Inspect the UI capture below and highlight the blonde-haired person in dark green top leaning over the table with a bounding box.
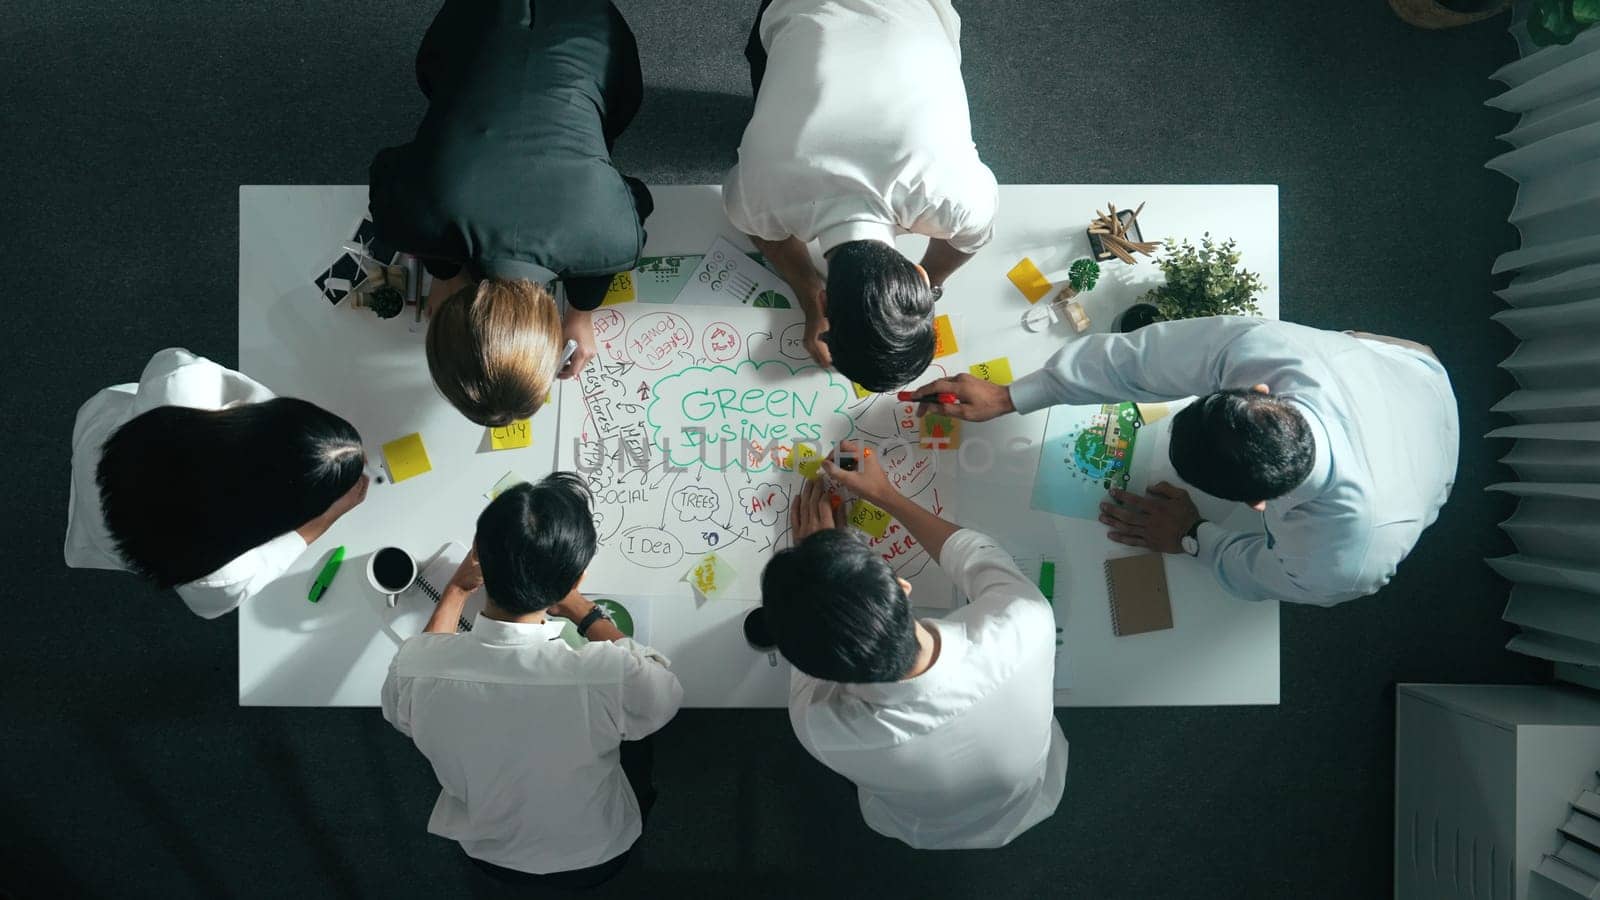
[368,0,654,426]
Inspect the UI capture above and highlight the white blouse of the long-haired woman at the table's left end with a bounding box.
[64,348,306,618]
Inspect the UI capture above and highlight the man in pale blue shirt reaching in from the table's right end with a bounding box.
[917,315,1461,605]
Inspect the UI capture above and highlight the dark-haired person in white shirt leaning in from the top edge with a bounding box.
[722,0,998,391]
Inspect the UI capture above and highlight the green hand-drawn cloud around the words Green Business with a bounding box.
[645,359,856,472]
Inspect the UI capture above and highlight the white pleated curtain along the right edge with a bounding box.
[1488,26,1600,687]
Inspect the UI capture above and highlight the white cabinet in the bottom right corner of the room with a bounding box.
[1395,684,1600,900]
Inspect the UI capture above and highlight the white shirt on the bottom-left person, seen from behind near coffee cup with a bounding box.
[382,613,683,874]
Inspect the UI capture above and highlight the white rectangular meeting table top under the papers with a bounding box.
[238,184,1280,706]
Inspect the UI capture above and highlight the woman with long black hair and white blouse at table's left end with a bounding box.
[64,348,368,618]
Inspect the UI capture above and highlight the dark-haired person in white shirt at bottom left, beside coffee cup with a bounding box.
[382,472,683,887]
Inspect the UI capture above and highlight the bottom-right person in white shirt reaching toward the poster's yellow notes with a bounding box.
[762,440,1067,850]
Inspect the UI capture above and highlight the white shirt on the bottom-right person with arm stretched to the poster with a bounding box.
[789,528,1067,850]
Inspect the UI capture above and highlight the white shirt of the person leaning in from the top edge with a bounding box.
[722,0,1000,253]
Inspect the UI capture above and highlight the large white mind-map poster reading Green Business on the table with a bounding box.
[557,304,960,609]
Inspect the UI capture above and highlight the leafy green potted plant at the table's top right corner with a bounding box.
[1117,234,1267,331]
